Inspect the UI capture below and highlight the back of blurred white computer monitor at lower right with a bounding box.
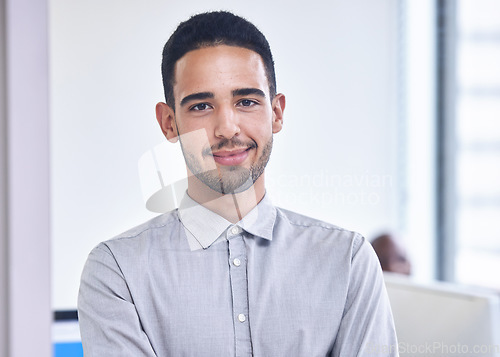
[385,274,500,357]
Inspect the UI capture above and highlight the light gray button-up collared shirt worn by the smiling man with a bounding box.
[78,195,397,357]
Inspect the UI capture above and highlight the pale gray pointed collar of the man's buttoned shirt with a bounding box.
[179,192,276,250]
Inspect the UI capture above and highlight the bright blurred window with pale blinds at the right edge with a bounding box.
[438,0,500,289]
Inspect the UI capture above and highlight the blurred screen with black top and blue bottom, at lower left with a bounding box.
[52,310,83,357]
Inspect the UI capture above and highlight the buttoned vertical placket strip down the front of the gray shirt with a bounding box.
[227,226,252,357]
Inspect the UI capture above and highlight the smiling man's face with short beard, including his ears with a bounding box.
[161,45,285,194]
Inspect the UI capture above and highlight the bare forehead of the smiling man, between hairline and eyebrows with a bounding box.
[174,45,269,100]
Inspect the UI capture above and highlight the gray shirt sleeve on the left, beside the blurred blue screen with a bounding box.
[78,244,156,357]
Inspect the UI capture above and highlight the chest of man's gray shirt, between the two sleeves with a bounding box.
[122,236,347,356]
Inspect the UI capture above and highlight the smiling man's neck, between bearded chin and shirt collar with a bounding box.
[188,174,265,223]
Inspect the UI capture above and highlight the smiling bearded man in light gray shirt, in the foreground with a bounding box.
[79,12,397,357]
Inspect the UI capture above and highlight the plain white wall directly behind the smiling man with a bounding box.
[50,0,401,309]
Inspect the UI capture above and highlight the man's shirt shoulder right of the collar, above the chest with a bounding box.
[275,207,367,256]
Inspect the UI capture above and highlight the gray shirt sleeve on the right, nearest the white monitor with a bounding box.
[332,235,399,357]
